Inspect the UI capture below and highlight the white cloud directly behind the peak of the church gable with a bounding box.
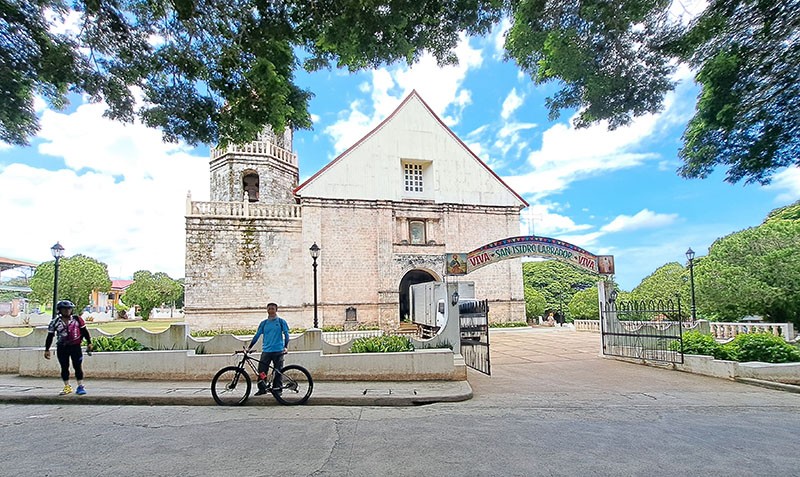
[324,37,483,154]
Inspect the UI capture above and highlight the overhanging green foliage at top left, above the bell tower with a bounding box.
[0,0,501,145]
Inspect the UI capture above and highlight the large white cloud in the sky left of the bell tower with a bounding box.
[0,104,209,278]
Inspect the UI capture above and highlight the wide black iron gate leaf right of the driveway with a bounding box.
[601,299,683,363]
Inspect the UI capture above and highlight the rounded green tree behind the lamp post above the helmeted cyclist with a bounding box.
[30,255,111,313]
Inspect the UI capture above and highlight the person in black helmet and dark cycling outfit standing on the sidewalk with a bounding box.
[44,300,92,396]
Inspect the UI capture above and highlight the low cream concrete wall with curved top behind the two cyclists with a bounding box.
[0,323,467,381]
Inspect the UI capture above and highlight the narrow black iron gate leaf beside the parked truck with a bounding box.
[458,300,492,375]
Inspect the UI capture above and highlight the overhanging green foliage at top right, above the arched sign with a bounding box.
[506,0,800,183]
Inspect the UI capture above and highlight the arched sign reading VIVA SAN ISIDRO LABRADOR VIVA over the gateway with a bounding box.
[462,235,600,273]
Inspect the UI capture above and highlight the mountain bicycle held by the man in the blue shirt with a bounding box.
[211,349,314,406]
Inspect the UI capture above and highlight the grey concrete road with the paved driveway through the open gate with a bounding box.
[0,330,800,476]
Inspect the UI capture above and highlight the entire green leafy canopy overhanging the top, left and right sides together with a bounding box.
[0,0,800,182]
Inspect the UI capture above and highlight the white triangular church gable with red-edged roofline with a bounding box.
[294,90,528,208]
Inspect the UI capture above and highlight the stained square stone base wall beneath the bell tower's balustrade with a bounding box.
[184,216,308,329]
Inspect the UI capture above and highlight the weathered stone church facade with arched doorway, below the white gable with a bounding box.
[301,198,525,328]
